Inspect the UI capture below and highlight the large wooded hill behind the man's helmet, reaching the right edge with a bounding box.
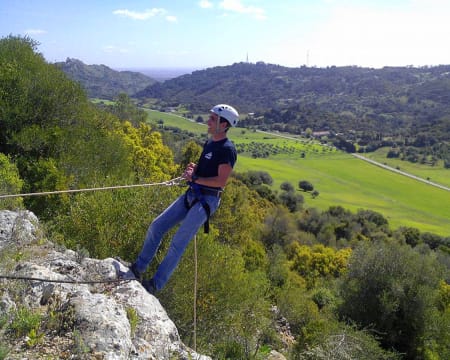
[136,63,450,146]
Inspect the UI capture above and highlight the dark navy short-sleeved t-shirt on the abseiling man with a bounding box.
[195,138,237,183]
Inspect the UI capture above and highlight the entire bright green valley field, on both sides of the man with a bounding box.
[147,112,450,236]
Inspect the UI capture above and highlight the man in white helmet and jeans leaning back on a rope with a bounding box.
[131,104,239,294]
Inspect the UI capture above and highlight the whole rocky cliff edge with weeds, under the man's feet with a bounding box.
[0,211,210,360]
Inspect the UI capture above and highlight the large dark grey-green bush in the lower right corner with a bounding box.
[339,241,442,359]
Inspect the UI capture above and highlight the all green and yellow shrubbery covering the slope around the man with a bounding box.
[0,36,450,360]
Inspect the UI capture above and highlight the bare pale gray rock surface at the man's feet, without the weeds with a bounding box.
[0,211,210,360]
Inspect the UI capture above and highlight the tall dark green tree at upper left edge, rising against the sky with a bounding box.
[0,36,85,157]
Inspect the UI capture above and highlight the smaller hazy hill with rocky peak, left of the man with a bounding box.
[55,58,156,99]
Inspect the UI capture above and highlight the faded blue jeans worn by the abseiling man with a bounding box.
[135,191,220,290]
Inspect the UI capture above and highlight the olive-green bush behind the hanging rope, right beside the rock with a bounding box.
[160,233,270,359]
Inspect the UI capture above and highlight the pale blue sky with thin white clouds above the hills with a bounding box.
[0,0,450,69]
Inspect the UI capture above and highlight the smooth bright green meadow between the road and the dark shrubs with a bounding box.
[236,153,450,236]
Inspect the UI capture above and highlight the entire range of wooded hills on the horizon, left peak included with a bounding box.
[61,59,450,168]
